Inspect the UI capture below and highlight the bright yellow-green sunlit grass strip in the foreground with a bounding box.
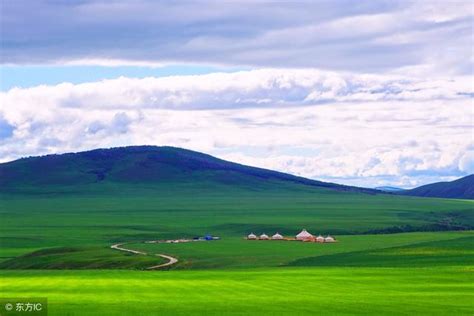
[0,267,474,315]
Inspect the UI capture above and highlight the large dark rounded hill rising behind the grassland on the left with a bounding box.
[0,146,380,194]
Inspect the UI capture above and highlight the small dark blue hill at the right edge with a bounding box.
[399,174,474,200]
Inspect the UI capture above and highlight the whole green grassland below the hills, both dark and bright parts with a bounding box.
[0,186,474,315]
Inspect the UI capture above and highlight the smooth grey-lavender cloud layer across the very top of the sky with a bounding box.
[0,0,474,75]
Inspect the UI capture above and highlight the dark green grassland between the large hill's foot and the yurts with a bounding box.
[0,185,474,267]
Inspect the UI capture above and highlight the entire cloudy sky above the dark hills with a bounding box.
[0,0,474,188]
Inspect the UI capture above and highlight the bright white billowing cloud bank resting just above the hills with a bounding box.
[0,69,474,187]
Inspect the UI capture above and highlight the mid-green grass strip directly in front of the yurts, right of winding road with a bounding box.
[128,232,474,269]
